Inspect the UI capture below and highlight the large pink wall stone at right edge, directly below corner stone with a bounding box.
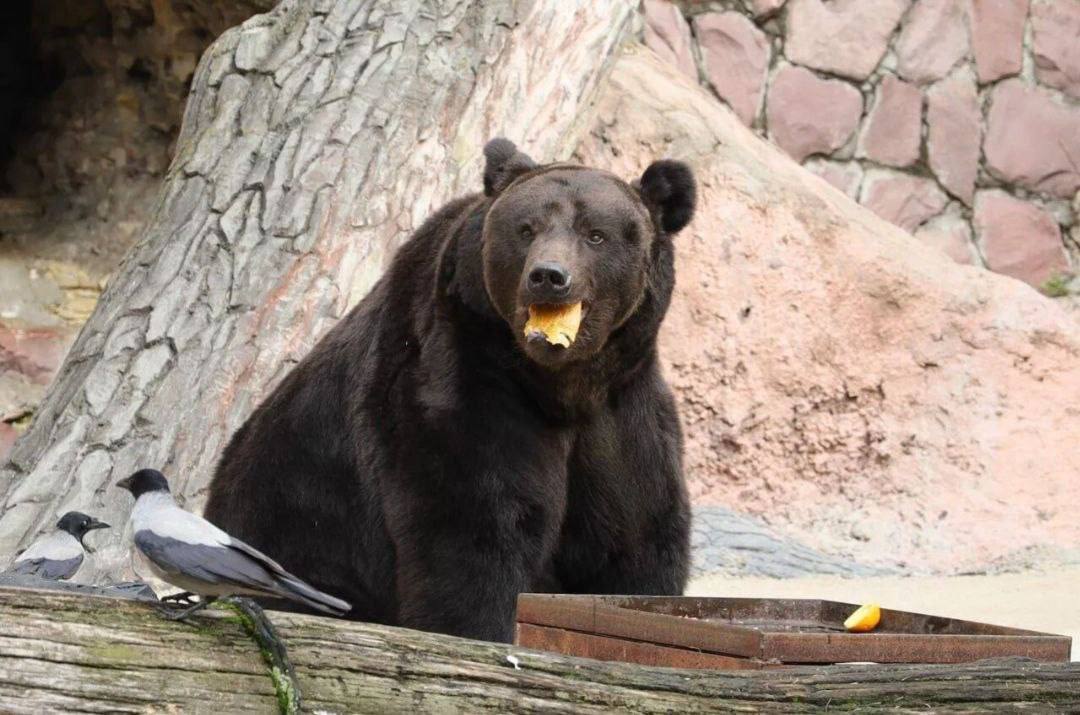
[983,80,1080,199]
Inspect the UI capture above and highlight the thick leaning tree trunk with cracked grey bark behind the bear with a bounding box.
[0,0,636,581]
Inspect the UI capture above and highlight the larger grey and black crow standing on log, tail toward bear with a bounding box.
[117,469,352,619]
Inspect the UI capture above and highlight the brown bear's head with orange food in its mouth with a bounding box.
[482,138,696,368]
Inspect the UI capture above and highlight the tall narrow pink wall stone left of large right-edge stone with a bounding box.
[927,68,983,206]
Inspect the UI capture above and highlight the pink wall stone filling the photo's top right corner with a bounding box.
[1031,0,1080,98]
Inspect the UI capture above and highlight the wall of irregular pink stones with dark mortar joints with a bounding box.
[644,0,1080,296]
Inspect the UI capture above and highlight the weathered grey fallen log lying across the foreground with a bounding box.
[0,589,1080,713]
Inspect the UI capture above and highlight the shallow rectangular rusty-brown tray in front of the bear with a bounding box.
[515,593,1072,669]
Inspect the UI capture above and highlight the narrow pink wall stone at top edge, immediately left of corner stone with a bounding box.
[970,0,1028,82]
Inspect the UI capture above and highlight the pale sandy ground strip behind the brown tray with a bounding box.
[687,567,1080,660]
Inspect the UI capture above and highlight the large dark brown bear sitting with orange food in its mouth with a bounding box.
[206,139,696,640]
